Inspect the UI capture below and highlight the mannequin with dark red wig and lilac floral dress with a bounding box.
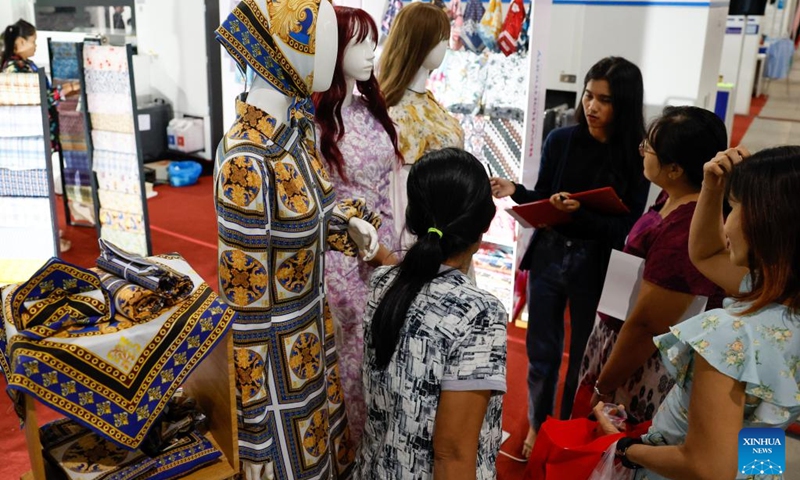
[313,7,402,445]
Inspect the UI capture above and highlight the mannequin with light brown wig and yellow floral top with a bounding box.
[379,2,464,249]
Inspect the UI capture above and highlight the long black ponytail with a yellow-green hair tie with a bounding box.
[370,148,495,370]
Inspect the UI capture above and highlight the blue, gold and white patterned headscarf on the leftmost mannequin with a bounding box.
[217,0,321,124]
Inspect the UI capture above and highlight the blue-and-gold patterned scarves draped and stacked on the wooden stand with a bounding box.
[0,246,235,479]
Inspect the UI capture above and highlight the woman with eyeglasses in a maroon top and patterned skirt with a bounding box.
[572,107,728,421]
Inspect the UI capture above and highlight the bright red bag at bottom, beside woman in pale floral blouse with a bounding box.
[523,417,651,480]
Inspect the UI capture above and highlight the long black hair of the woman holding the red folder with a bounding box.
[575,57,645,197]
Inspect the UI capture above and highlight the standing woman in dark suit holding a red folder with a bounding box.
[492,57,649,457]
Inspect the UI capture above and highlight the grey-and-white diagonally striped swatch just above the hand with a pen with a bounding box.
[483,118,525,182]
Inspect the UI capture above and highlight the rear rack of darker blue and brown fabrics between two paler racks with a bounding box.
[47,38,97,227]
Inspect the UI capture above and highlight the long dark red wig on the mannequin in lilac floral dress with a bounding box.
[312,7,403,181]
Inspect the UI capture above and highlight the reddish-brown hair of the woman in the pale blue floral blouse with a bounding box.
[728,146,800,315]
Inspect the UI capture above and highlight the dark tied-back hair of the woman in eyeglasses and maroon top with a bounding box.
[647,107,728,191]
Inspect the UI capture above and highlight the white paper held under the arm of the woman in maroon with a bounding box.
[597,250,708,322]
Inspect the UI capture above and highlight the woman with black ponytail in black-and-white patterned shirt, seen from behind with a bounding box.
[356,148,508,479]
